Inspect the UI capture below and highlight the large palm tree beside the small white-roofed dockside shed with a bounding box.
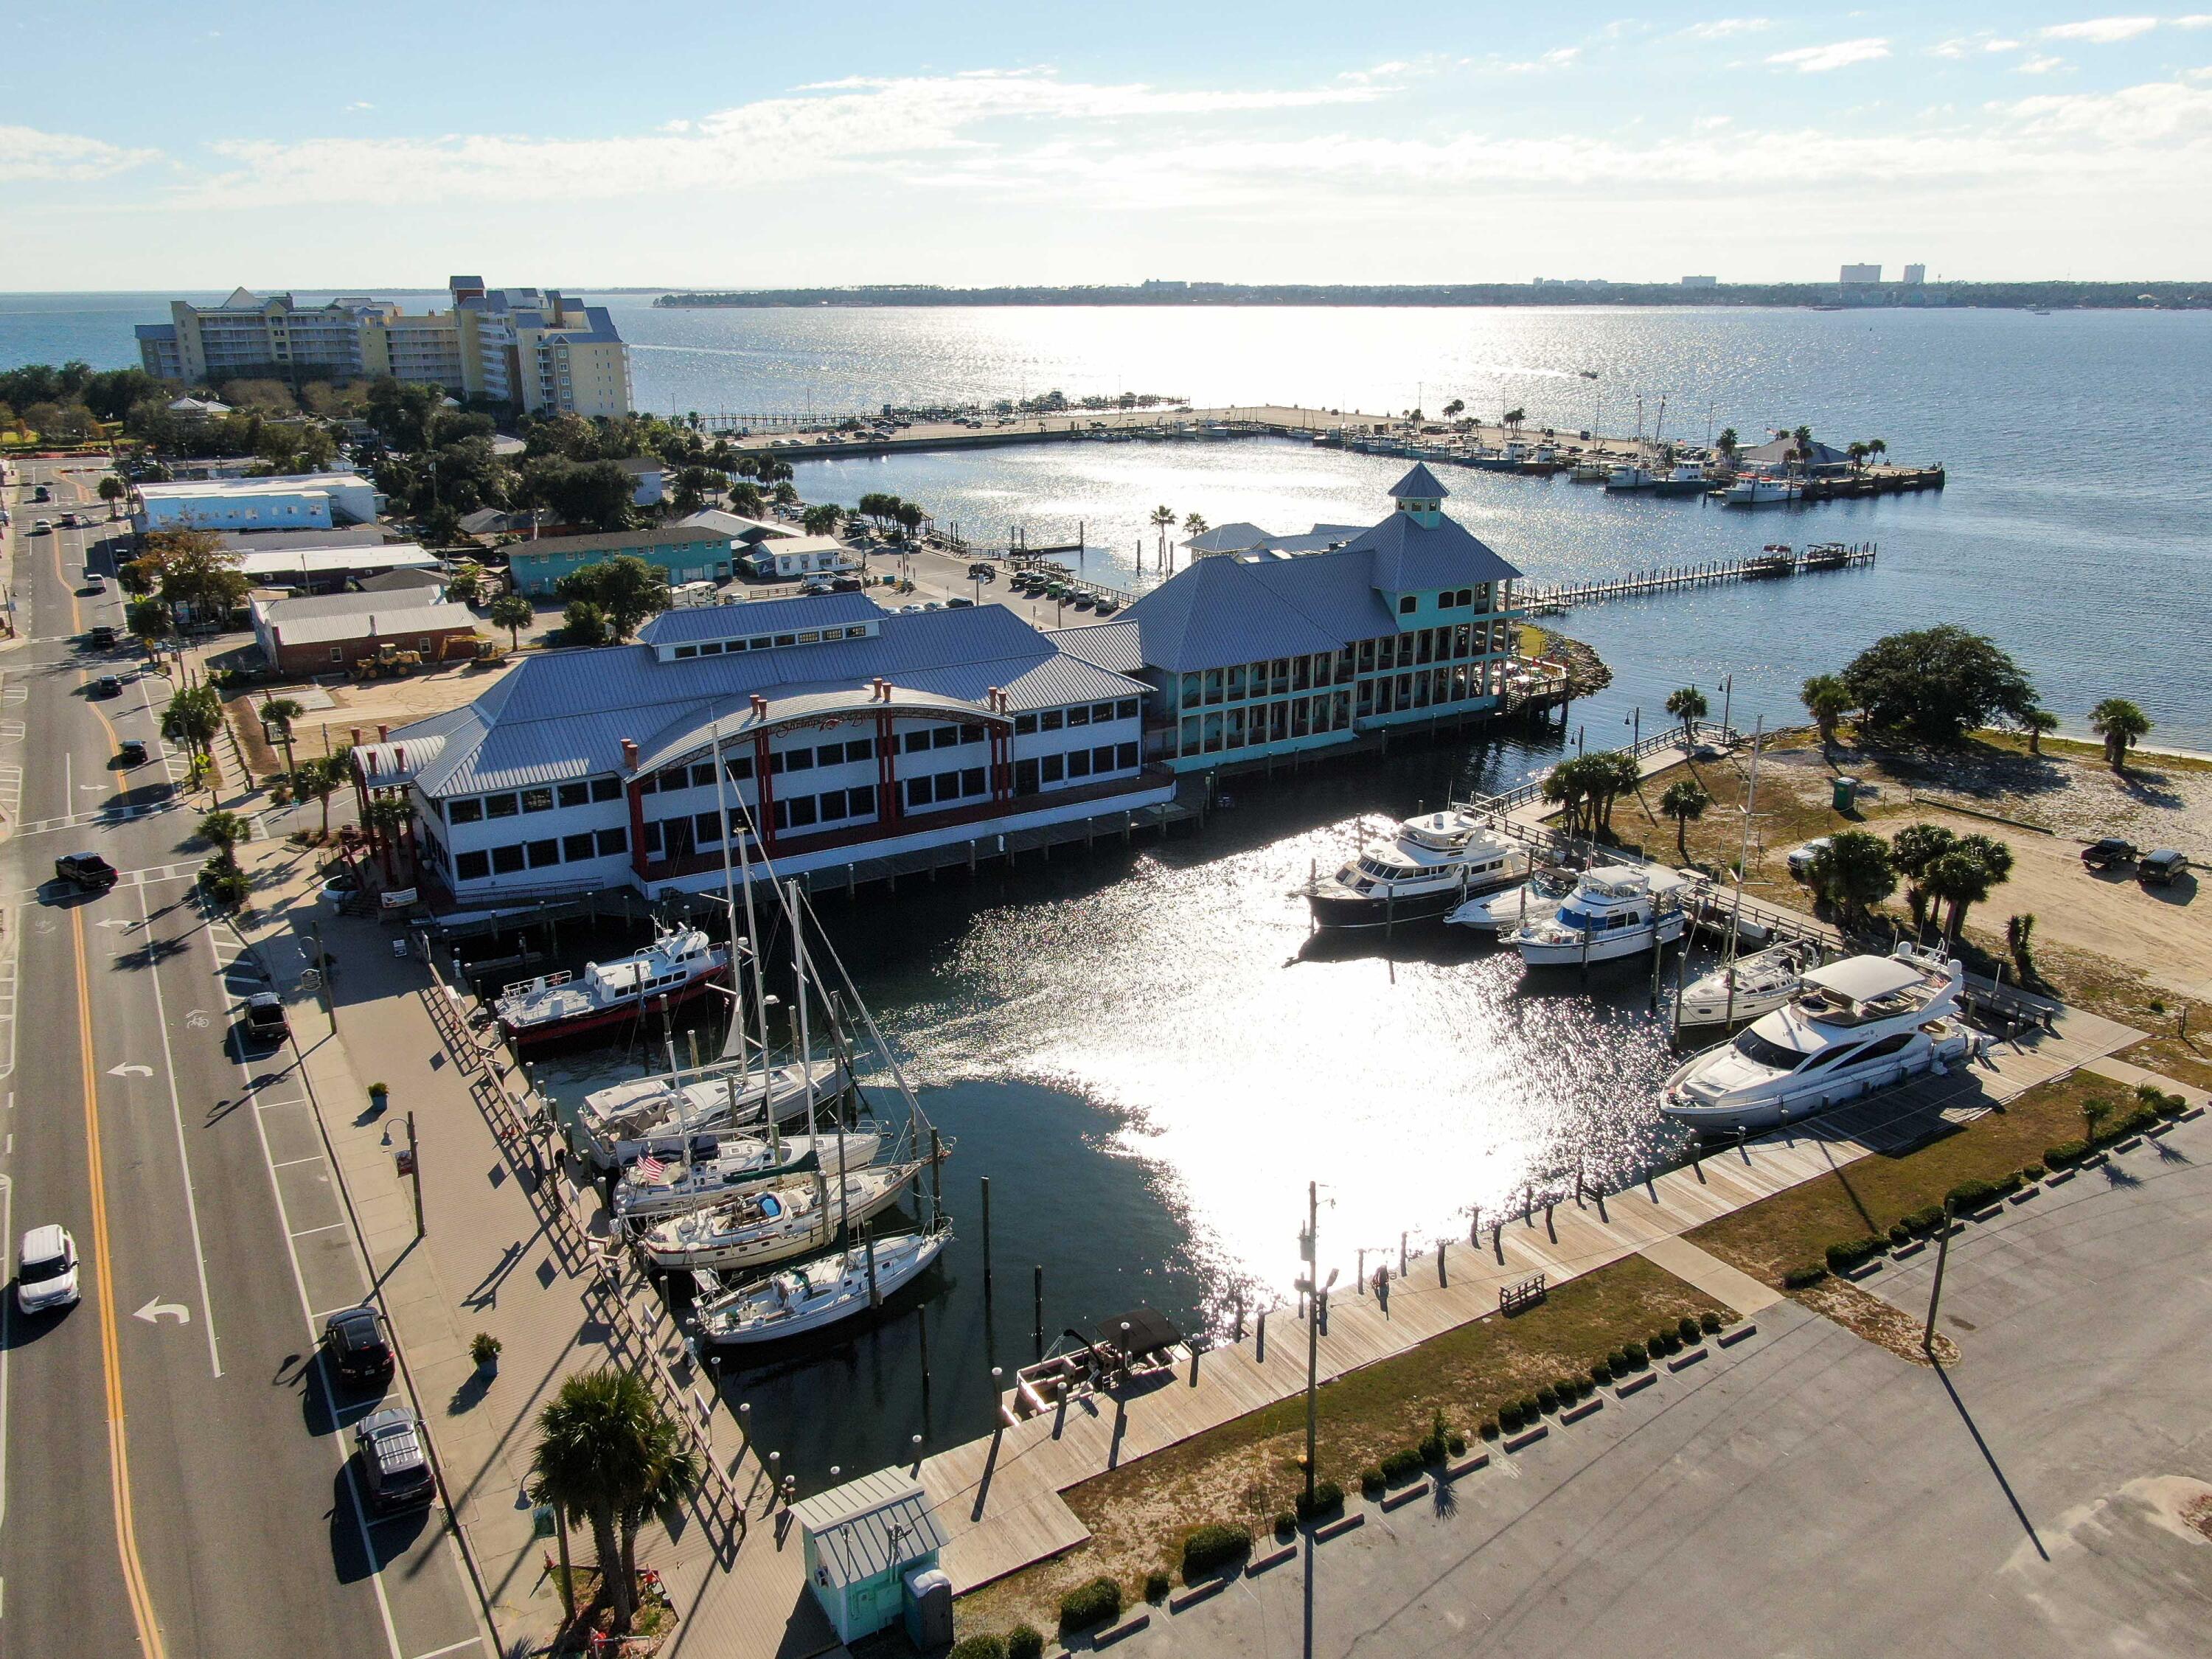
[531,1367,701,1635]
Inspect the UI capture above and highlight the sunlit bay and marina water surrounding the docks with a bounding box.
[17,296,2212,1480]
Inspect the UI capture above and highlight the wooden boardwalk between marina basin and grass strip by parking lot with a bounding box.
[920,1011,2139,1593]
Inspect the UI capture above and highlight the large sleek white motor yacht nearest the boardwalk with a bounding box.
[1661,942,1978,1135]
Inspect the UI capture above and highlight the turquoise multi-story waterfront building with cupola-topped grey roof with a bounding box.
[1051,465,1522,772]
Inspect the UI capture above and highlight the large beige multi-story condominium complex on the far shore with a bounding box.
[137,276,630,416]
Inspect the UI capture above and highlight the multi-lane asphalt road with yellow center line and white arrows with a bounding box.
[0,462,489,1659]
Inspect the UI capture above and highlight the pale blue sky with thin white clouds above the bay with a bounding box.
[0,0,2212,292]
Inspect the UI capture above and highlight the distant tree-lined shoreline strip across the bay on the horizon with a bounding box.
[653,281,2212,312]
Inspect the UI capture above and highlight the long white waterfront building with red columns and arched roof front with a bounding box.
[354,593,1175,905]
